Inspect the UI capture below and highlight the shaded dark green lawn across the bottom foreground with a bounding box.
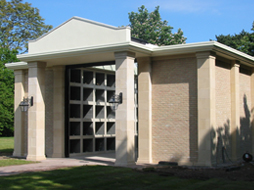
[0,166,254,190]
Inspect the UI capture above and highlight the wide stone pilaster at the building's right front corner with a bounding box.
[196,52,215,166]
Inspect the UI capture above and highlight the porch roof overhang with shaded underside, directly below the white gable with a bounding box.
[14,42,152,66]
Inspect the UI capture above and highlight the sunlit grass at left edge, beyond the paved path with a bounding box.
[0,137,35,167]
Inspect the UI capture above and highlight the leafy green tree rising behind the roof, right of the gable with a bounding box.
[128,5,186,46]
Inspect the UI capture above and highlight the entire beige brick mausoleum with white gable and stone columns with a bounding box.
[6,17,254,166]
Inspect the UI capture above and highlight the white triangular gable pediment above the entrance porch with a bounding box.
[28,16,131,54]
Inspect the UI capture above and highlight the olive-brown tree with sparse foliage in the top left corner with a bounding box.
[0,0,52,53]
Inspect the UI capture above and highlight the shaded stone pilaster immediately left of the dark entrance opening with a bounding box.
[52,66,65,158]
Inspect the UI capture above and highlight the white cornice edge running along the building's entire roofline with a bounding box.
[6,41,254,69]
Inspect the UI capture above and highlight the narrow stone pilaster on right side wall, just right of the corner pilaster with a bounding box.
[230,61,240,161]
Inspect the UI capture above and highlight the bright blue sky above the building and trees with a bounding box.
[23,0,254,43]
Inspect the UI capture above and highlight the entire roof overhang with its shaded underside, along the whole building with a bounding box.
[6,41,254,70]
